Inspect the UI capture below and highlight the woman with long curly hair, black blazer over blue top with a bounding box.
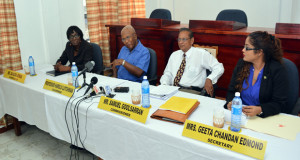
[224,31,288,117]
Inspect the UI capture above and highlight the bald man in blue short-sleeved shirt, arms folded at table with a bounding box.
[111,25,150,82]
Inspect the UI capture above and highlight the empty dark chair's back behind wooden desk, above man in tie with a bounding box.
[216,9,248,26]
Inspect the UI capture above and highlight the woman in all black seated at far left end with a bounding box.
[54,26,93,72]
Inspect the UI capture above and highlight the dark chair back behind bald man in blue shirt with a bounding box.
[146,47,157,85]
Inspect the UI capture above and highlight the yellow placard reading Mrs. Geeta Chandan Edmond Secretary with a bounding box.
[182,120,267,159]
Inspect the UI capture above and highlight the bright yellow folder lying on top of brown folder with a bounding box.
[159,96,198,114]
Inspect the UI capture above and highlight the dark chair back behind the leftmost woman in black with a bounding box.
[91,43,104,74]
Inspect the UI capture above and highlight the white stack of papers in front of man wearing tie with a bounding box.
[150,85,179,100]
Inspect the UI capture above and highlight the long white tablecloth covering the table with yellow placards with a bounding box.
[0,66,300,160]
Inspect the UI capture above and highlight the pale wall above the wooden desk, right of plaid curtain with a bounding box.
[146,0,300,28]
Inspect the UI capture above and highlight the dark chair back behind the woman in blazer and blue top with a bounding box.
[283,58,299,114]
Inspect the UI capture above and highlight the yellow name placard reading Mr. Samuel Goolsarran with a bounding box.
[98,96,150,123]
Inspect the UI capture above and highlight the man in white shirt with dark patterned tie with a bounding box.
[160,28,224,97]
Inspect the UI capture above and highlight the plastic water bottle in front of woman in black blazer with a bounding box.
[230,92,243,132]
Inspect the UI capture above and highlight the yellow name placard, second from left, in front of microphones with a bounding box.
[43,79,75,97]
